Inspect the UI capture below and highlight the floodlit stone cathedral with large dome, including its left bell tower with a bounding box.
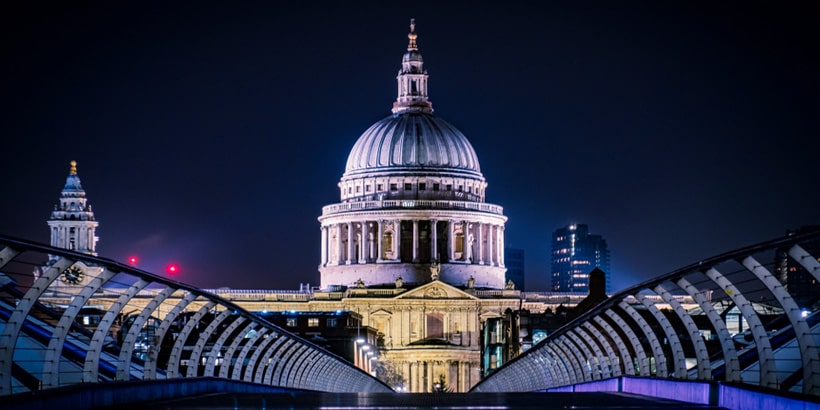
[40,21,586,392]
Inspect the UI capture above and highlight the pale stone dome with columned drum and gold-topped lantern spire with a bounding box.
[319,20,507,289]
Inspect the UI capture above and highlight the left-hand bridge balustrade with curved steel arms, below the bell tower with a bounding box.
[0,236,392,396]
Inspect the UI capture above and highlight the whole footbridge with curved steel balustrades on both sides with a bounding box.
[0,230,820,408]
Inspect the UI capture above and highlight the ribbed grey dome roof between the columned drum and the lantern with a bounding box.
[345,110,483,179]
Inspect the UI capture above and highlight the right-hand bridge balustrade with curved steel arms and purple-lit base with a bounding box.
[472,228,820,396]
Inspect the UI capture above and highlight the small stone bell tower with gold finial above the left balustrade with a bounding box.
[48,161,100,256]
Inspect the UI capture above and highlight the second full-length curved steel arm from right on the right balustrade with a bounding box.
[704,268,779,389]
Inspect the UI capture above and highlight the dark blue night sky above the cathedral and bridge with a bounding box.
[0,1,820,290]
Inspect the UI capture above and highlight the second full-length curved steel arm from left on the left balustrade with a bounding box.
[42,269,115,388]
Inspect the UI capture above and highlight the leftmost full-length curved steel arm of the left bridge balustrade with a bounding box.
[0,253,74,395]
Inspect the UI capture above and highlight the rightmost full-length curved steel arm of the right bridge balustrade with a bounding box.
[743,256,820,395]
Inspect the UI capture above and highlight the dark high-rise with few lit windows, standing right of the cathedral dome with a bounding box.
[552,224,611,292]
